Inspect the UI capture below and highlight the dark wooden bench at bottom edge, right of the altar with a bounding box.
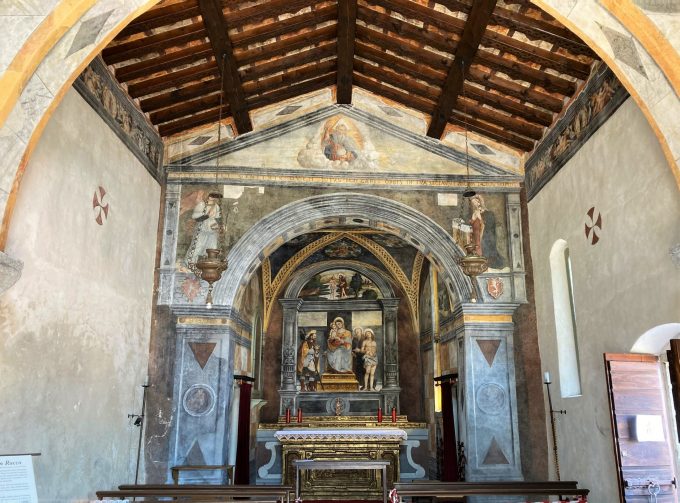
[394,480,590,501]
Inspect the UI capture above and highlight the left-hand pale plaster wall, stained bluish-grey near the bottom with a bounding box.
[0,90,160,502]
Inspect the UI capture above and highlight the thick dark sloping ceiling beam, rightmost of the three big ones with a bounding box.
[427,0,496,139]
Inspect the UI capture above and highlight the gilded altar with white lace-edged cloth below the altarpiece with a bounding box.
[274,427,407,500]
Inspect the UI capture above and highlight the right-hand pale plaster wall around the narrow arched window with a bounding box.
[529,99,680,501]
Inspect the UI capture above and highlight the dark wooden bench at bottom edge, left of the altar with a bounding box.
[96,484,293,503]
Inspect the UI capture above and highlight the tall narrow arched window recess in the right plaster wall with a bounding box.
[550,239,581,397]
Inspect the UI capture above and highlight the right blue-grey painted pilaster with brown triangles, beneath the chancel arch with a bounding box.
[454,303,523,481]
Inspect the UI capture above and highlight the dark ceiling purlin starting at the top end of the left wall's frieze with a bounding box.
[102,22,208,65]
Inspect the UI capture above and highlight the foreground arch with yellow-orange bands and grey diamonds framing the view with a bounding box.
[0,0,680,250]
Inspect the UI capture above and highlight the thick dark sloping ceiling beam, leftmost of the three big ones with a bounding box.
[198,0,253,134]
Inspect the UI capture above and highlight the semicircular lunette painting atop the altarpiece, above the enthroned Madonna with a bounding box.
[299,270,382,300]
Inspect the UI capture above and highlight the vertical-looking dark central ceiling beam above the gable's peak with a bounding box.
[336,0,357,105]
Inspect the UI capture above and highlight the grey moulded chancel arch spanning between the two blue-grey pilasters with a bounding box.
[213,193,471,306]
